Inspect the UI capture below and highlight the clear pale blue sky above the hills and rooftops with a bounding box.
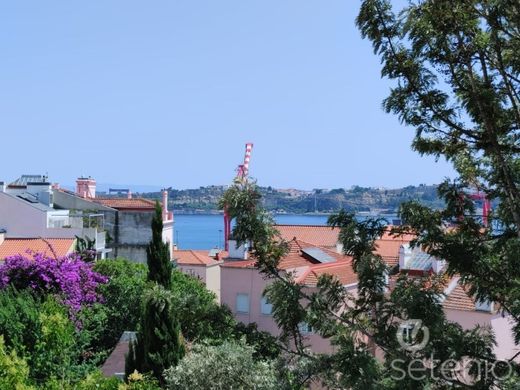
[0,0,452,189]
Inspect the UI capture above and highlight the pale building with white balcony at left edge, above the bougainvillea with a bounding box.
[0,175,108,258]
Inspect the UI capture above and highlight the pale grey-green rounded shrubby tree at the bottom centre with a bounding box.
[165,341,279,390]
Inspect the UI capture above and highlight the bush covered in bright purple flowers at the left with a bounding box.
[0,253,108,313]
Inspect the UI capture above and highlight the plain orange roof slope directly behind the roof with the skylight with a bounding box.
[275,225,339,249]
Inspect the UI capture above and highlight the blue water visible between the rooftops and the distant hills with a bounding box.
[175,214,328,249]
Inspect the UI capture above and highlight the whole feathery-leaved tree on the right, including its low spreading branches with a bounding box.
[220,0,520,388]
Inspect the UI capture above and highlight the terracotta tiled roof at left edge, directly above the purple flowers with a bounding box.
[0,238,74,260]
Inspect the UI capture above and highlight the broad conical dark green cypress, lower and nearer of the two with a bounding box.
[125,284,185,383]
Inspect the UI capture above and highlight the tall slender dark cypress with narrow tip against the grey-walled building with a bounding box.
[146,202,172,290]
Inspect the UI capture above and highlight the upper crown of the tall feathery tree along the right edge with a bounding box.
[357,0,520,352]
